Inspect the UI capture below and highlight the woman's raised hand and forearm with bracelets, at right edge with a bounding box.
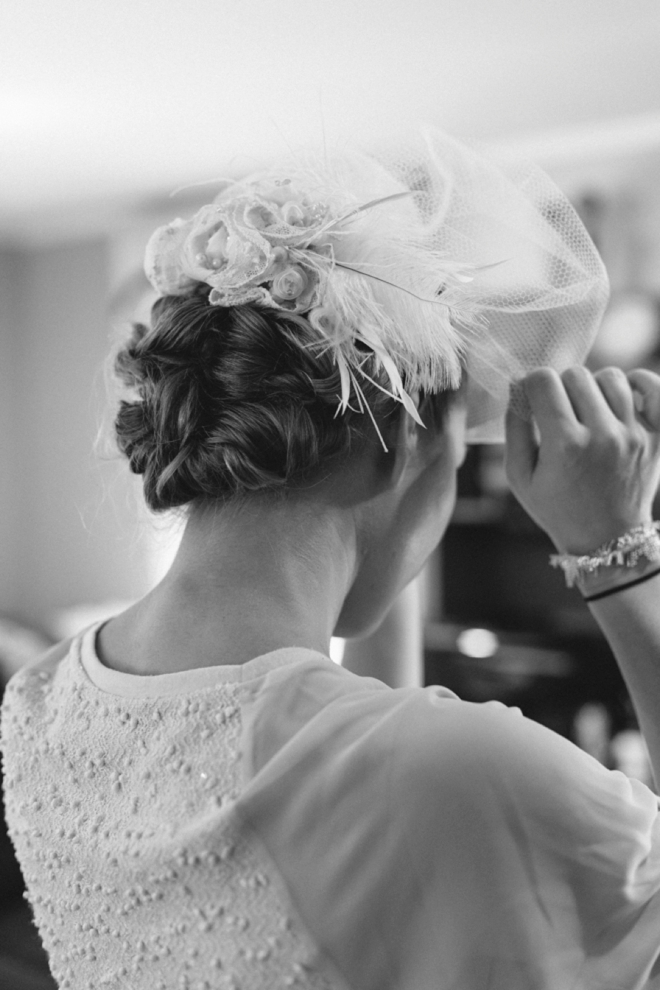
[507,367,660,787]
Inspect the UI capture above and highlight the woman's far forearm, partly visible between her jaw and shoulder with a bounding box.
[342,580,424,687]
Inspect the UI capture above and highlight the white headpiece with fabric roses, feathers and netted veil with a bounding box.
[145,128,608,443]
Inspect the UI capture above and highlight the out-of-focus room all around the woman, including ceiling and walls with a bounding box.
[0,0,660,990]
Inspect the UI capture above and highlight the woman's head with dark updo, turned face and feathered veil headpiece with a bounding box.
[109,132,606,634]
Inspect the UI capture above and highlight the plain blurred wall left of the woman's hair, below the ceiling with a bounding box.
[0,240,148,624]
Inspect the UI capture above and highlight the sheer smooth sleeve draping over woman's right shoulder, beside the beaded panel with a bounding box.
[241,666,660,990]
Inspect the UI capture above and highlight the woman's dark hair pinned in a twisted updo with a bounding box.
[115,287,456,511]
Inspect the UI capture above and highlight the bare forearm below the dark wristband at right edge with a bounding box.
[585,562,660,789]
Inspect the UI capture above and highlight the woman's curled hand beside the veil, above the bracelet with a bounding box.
[506,367,660,554]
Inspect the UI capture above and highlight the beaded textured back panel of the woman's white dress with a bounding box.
[2,658,336,990]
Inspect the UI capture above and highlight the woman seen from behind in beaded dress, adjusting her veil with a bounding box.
[2,134,660,990]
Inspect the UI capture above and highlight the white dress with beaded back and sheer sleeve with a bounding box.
[2,626,660,990]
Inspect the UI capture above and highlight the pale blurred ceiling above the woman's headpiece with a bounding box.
[0,0,660,241]
